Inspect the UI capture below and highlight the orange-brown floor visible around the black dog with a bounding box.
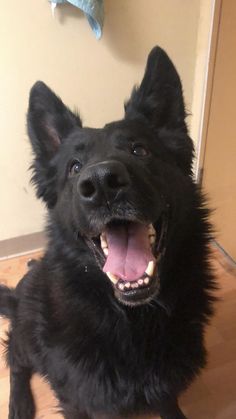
[0,251,236,419]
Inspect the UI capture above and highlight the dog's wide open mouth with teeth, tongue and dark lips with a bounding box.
[85,215,167,306]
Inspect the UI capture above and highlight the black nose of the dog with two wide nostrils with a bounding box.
[78,160,130,204]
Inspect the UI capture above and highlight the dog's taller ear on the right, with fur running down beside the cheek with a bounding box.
[125,47,193,175]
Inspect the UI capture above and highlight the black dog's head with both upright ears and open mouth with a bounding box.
[28,47,193,305]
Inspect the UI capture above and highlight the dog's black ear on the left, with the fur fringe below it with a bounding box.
[27,81,82,208]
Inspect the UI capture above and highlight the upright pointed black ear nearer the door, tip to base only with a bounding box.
[125,47,186,131]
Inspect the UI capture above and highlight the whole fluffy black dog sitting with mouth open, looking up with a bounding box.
[0,47,214,419]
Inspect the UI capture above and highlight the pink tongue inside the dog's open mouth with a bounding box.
[103,223,154,281]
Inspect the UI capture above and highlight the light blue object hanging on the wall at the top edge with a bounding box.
[49,0,104,39]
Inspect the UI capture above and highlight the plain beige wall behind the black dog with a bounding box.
[0,0,207,240]
